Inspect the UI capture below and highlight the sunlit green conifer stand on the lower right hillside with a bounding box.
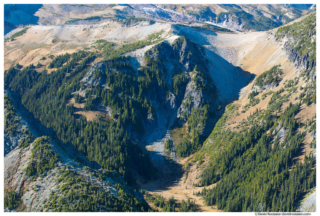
[200,103,316,212]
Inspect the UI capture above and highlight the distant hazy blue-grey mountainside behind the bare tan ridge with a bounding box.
[5,4,315,34]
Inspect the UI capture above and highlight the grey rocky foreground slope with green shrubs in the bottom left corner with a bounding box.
[4,92,149,211]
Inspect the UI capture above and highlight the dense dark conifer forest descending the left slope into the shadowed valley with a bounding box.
[5,51,157,184]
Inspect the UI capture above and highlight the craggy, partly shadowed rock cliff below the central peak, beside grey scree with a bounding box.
[139,37,219,137]
